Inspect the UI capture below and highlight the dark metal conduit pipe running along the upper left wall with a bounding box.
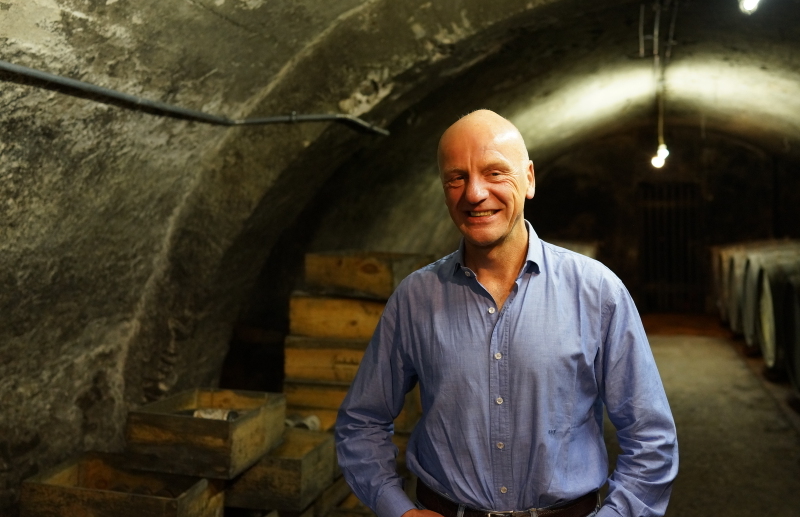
[0,61,389,136]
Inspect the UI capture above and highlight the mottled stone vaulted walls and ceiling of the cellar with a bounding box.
[0,0,800,515]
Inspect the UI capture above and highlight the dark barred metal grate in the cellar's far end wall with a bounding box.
[637,182,705,312]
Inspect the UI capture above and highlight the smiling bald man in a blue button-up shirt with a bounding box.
[336,110,678,517]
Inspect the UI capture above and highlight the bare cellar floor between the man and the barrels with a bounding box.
[606,315,800,517]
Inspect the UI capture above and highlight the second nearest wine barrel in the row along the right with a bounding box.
[756,251,800,373]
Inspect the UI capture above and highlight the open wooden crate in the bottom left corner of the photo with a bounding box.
[20,453,225,517]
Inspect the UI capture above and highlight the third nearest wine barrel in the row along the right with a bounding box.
[741,247,800,347]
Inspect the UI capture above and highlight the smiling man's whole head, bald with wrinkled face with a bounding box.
[439,110,536,252]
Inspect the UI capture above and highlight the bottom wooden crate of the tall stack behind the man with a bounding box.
[283,379,422,432]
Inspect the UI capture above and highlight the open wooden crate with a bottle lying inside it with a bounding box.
[125,389,286,479]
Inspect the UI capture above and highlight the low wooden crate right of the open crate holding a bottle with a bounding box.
[225,429,336,511]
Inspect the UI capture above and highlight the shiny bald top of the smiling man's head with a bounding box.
[438,109,529,173]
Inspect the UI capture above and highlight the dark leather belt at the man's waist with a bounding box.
[417,479,600,517]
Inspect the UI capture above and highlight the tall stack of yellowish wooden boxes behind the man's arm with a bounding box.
[284,252,431,513]
